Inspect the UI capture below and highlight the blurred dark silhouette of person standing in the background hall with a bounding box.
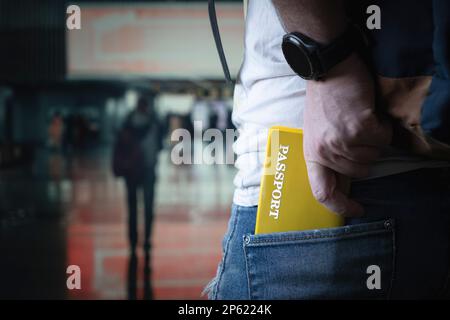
[113,97,162,258]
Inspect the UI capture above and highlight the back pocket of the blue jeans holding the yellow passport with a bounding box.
[244,219,395,299]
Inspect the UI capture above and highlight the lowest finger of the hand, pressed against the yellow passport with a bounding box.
[306,162,364,217]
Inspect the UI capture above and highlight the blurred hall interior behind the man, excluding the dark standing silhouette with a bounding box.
[0,0,244,299]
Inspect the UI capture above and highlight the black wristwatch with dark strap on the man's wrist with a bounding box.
[282,25,368,80]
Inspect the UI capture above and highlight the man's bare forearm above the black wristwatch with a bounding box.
[272,0,347,43]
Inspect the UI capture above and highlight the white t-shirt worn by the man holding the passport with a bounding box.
[233,0,449,206]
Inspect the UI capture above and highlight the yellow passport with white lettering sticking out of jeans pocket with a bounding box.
[255,127,344,234]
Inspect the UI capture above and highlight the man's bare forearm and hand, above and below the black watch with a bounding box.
[272,0,391,216]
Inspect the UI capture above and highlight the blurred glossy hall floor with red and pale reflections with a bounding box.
[0,150,235,299]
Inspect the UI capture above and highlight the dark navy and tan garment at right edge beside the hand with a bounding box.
[347,0,450,160]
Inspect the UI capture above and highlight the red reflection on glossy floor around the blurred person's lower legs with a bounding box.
[67,220,225,299]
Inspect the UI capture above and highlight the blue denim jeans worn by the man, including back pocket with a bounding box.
[206,168,450,299]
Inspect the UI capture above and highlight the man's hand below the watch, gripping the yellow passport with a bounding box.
[304,54,391,216]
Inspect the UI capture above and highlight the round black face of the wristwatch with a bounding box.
[282,35,314,80]
